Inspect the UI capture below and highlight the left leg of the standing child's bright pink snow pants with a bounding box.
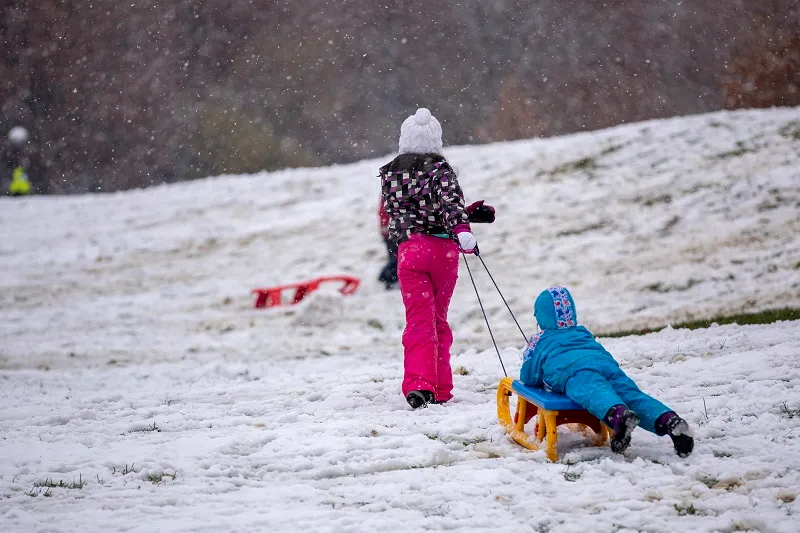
[397,236,438,396]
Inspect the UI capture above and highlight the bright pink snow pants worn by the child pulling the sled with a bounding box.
[397,234,458,402]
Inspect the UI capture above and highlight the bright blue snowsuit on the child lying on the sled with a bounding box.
[520,287,672,433]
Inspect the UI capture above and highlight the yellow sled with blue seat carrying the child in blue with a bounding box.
[497,377,609,462]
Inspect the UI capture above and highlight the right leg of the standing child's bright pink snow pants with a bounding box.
[431,237,458,402]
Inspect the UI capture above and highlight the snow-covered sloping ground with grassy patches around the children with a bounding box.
[0,108,800,532]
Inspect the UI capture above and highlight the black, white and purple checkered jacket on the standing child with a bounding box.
[380,154,470,244]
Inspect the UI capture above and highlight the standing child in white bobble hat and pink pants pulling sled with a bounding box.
[380,108,494,409]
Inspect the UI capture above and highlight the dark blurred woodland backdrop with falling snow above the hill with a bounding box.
[0,0,800,193]
